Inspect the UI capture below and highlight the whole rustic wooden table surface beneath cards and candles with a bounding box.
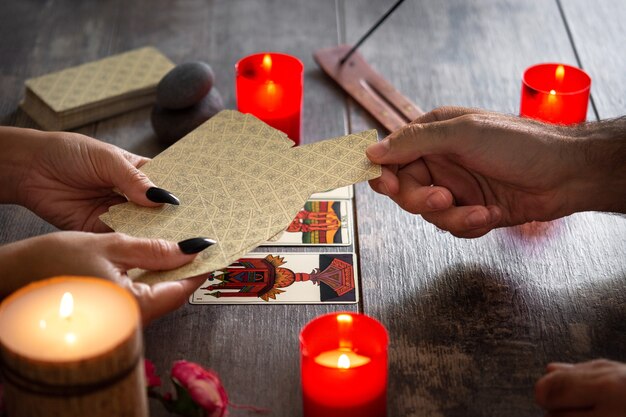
[0,0,626,416]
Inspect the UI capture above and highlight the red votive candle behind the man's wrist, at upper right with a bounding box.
[520,63,591,125]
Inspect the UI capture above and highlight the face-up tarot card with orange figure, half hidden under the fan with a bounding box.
[263,200,353,246]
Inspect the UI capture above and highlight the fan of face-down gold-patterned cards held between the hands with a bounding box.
[101,110,381,283]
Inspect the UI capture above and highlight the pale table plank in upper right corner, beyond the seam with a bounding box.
[561,0,626,119]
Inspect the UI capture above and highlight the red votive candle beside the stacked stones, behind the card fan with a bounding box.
[235,52,304,145]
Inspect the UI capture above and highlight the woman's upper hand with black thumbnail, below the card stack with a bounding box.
[0,127,178,232]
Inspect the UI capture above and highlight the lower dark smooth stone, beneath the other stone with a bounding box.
[150,88,224,146]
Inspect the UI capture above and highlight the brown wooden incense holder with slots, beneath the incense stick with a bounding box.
[313,45,424,132]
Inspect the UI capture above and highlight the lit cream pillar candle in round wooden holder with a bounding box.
[0,277,147,416]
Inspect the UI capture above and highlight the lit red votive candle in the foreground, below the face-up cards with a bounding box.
[300,312,388,417]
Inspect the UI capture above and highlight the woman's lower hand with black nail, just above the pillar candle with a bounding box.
[0,232,214,323]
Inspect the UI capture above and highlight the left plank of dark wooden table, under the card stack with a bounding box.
[0,0,357,416]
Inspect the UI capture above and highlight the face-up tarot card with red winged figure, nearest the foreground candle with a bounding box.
[189,253,358,304]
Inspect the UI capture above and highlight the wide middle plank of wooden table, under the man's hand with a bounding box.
[342,0,626,416]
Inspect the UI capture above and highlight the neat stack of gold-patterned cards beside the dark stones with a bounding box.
[20,47,174,130]
